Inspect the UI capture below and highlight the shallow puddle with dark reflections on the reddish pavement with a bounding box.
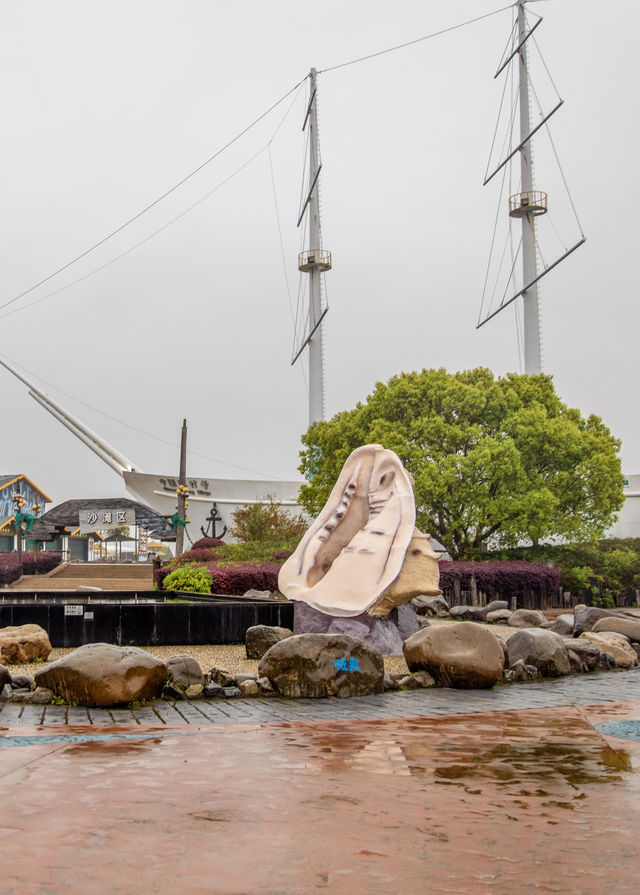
[270,710,633,806]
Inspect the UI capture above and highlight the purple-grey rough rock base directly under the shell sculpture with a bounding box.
[293,601,420,656]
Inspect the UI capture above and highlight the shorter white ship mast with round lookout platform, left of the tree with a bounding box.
[291,68,331,425]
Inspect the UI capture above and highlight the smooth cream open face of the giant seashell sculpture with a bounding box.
[278,444,416,616]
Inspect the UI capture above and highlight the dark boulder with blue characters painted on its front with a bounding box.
[258,634,384,697]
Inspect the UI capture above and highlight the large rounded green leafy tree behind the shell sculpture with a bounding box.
[300,368,623,559]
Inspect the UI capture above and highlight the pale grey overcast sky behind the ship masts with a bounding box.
[0,0,640,502]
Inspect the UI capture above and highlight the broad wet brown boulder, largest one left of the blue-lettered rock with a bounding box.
[35,643,168,706]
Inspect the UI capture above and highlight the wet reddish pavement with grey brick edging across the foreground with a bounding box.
[0,671,640,895]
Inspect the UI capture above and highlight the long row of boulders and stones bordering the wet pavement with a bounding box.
[0,596,640,706]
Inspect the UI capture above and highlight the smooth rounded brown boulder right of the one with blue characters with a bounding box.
[404,622,504,689]
